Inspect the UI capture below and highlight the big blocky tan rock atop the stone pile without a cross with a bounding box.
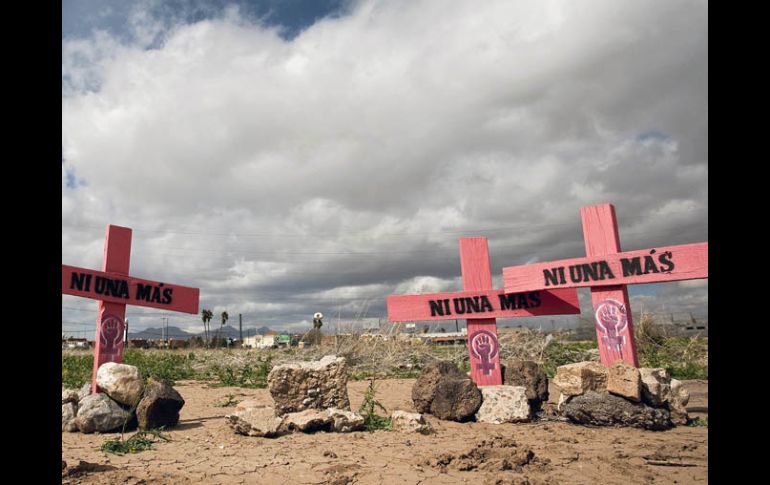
[267,355,350,416]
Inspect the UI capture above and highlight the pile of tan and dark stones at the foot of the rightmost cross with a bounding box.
[554,361,690,430]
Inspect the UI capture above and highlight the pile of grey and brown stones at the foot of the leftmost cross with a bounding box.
[62,362,184,433]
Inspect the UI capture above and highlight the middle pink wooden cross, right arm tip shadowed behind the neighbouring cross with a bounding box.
[387,237,580,386]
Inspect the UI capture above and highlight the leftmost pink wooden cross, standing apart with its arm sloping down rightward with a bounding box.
[61,225,200,393]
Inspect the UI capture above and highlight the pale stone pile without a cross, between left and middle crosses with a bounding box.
[225,355,429,438]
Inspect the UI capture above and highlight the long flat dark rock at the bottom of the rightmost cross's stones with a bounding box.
[563,391,672,430]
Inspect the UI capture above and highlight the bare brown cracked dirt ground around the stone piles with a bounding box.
[62,379,708,485]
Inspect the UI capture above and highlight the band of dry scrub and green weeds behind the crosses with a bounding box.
[62,324,708,388]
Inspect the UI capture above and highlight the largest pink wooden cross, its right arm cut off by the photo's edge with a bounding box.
[503,204,708,367]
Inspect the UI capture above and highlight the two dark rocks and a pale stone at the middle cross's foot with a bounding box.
[412,360,548,424]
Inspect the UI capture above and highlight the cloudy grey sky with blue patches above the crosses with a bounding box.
[62,0,708,337]
